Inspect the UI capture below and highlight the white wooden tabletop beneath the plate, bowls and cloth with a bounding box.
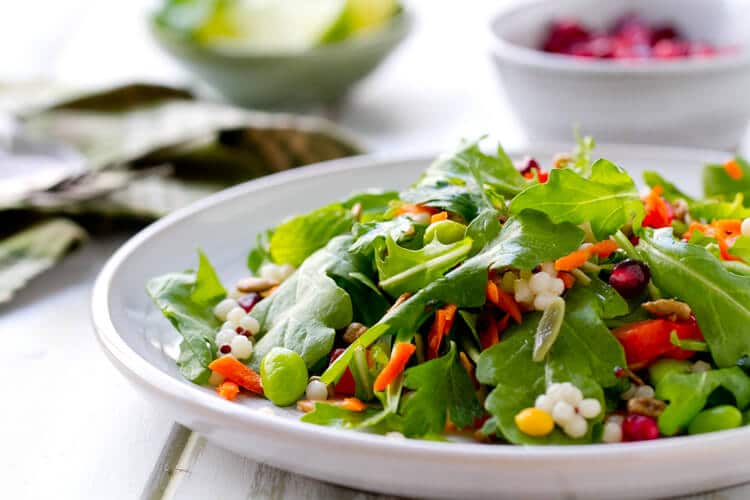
[0,0,750,500]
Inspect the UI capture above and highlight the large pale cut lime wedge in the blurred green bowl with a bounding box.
[195,0,347,52]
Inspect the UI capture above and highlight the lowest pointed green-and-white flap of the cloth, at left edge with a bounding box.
[0,218,86,303]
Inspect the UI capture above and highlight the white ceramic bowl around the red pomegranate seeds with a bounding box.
[491,0,750,149]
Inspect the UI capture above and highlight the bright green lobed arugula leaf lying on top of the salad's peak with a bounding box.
[510,160,644,239]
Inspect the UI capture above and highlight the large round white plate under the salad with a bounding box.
[92,146,750,499]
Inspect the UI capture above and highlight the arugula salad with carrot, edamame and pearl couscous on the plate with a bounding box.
[147,137,750,445]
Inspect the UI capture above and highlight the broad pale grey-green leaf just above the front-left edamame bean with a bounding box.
[250,236,353,368]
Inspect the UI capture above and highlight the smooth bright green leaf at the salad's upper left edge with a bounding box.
[269,203,354,267]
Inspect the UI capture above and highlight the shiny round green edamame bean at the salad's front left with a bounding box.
[260,347,307,406]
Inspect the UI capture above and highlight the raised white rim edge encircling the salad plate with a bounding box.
[90,143,750,464]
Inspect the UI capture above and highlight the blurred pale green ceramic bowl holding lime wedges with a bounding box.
[150,10,412,107]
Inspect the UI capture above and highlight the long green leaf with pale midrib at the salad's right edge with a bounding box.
[638,228,750,368]
